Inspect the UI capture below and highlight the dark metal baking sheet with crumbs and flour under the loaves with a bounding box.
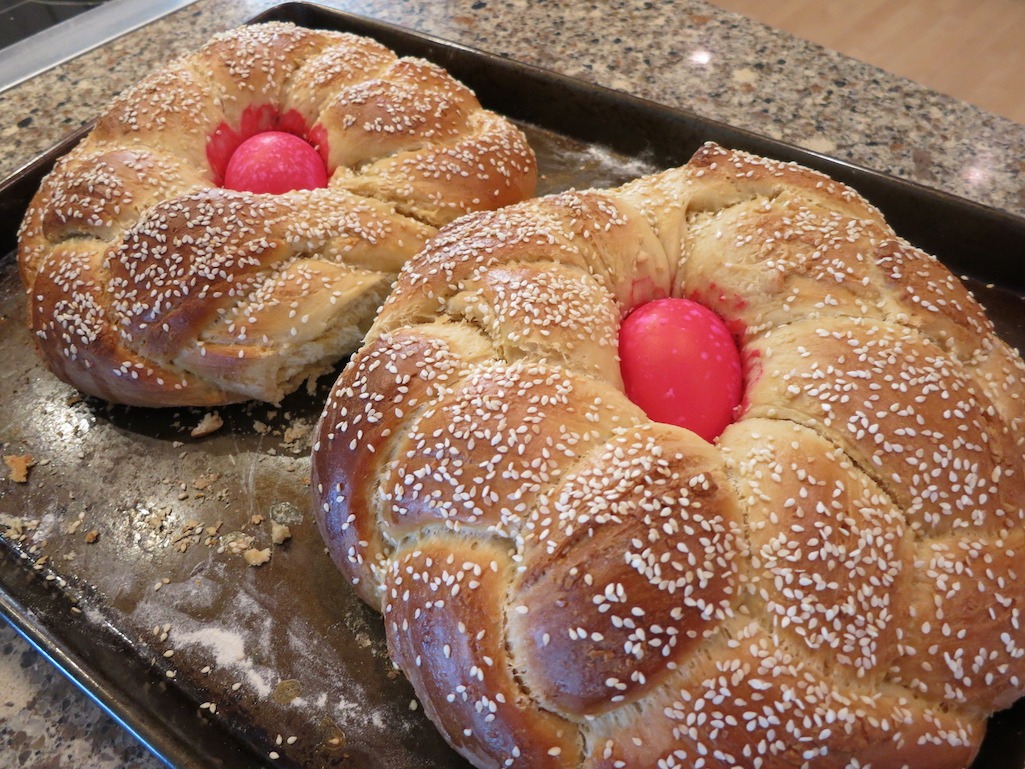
[0,3,1025,769]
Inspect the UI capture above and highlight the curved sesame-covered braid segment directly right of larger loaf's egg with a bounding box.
[747,318,1023,534]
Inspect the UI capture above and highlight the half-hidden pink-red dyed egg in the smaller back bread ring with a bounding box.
[224,131,327,195]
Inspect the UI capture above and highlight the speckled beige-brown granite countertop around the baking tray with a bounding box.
[0,0,1025,769]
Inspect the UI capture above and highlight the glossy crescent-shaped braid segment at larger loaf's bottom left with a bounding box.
[384,532,582,769]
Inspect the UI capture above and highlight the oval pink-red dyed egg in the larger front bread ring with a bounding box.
[619,297,743,442]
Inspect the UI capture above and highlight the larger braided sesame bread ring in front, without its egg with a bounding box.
[313,145,1025,769]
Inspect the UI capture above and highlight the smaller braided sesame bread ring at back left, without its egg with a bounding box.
[18,23,536,406]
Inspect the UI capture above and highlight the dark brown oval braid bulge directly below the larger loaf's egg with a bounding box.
[508,422,742,719]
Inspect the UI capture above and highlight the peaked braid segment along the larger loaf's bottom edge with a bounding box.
[583,617,985,769]
